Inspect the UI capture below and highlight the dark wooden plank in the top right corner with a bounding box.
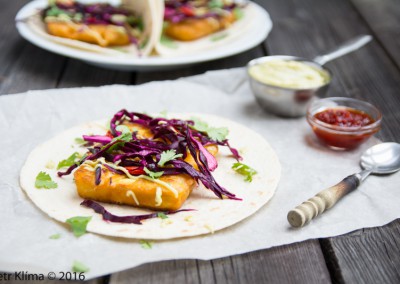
[351,0,400,68]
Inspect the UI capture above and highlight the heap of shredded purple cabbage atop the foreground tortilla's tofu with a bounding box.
[58,109,241,200]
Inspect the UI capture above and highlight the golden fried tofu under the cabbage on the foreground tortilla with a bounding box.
[74,124,218,210]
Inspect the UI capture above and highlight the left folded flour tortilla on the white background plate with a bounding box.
[27,0,162,56]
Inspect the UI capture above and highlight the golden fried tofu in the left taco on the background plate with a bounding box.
[47,21,130,47]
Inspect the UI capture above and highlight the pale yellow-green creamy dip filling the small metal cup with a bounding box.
[249,60,330,89]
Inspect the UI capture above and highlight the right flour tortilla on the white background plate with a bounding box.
[155,2,257,57]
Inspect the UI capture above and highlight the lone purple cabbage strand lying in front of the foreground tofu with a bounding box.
[81,199,195,225]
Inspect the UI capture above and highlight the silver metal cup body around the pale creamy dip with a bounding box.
[247,55,332,117]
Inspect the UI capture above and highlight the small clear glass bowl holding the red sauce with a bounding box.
[307,97,382,150]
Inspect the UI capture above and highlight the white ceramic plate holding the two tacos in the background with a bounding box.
[15,0,272,71]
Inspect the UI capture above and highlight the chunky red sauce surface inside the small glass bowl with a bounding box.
[314,107,375,127]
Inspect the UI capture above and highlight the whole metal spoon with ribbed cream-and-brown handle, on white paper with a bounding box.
[287,142,400,227]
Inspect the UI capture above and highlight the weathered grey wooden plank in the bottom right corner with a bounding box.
[321,220,400,284]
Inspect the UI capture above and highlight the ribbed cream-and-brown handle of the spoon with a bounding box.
[287,174,361,227]
